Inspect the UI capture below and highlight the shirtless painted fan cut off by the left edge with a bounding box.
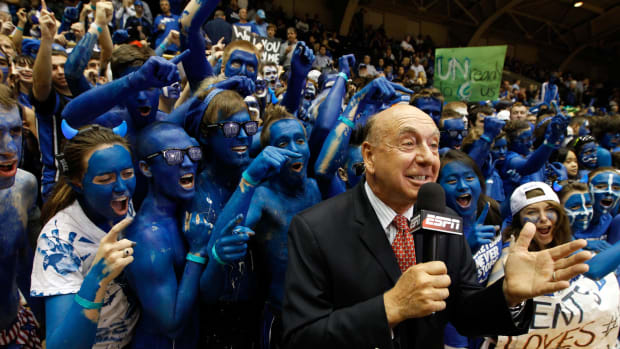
[0,85,41,348]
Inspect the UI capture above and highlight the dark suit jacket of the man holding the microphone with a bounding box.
[283,181,532,349]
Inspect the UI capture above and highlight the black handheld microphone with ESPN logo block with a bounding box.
[411,182,463,263]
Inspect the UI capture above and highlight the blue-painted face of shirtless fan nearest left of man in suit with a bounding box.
[269,119,310,185]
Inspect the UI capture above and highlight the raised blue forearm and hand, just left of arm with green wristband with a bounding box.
[280,41,314,114]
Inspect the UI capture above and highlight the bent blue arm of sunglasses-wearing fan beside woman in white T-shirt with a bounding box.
[126,235,206,338]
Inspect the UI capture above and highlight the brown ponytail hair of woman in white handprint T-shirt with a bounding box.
[41,125,131,224]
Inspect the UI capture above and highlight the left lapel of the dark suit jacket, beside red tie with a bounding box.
[353,181,402,283]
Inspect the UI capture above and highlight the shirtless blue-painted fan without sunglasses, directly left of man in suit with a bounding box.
[246,106,321,348]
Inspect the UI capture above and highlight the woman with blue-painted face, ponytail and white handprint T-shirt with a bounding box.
[30,125,140,349]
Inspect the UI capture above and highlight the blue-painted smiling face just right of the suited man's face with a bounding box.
[438,161,482,218]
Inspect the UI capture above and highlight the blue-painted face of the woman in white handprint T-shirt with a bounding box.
[81,144,136,222]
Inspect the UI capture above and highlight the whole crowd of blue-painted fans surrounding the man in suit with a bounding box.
[0,0,620,348]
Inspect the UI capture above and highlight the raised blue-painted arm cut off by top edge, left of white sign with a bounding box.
[181,0,220,92]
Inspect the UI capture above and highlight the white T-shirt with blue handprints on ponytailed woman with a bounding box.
[30,200,140,349]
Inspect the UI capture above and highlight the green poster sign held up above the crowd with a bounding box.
[433,45,506,102]
